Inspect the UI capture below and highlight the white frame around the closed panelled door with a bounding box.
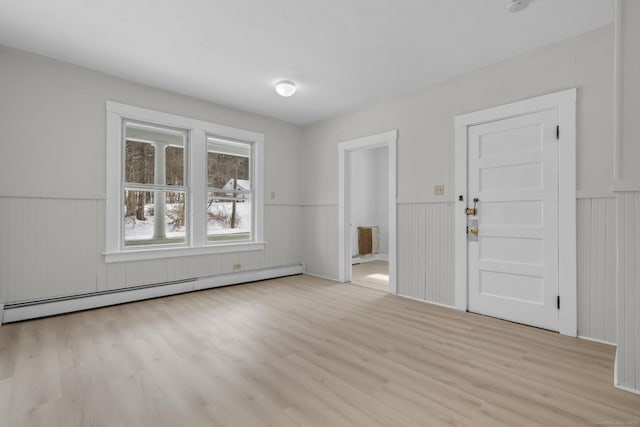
[454,88,578,337]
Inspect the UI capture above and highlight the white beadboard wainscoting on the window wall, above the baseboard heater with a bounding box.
[0,197,303,304]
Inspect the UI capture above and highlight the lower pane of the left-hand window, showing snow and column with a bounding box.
[124,189,187,247]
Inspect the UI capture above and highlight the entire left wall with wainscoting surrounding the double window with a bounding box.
[0,47,302,303]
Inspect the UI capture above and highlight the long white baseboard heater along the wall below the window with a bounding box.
[0,263,304,324]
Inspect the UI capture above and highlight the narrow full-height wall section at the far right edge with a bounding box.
[615,0,640,393]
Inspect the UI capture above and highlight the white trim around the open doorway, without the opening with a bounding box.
[338,130,398,295]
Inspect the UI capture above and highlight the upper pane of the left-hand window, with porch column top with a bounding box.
[125,123,186,186]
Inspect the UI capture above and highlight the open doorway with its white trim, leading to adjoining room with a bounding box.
[338,131,397,294]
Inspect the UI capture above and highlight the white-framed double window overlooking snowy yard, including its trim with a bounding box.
[105,101,264,262]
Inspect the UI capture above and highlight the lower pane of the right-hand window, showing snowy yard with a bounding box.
[207,193,253,241]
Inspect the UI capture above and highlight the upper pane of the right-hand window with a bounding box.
[207,138,251,191]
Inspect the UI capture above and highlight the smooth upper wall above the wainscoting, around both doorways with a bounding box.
[302,26,613,208]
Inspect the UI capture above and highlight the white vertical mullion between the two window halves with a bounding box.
[188,129,207,246]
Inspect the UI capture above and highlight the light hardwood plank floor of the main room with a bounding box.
[0,276,640,427]
